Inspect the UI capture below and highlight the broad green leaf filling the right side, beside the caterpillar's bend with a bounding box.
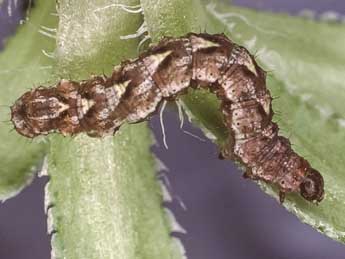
[209,3,345,242]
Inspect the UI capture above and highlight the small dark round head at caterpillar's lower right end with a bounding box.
[300,168,324,202]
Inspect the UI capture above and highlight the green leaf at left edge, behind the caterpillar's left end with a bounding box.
[0,1,57,200]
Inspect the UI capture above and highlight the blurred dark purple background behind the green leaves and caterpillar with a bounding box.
[0,0,345,259]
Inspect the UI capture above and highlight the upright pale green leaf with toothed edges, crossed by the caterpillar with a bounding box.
[46,0,182,259]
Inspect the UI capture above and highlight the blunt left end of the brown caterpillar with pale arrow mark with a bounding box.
[11,87,69,138]
